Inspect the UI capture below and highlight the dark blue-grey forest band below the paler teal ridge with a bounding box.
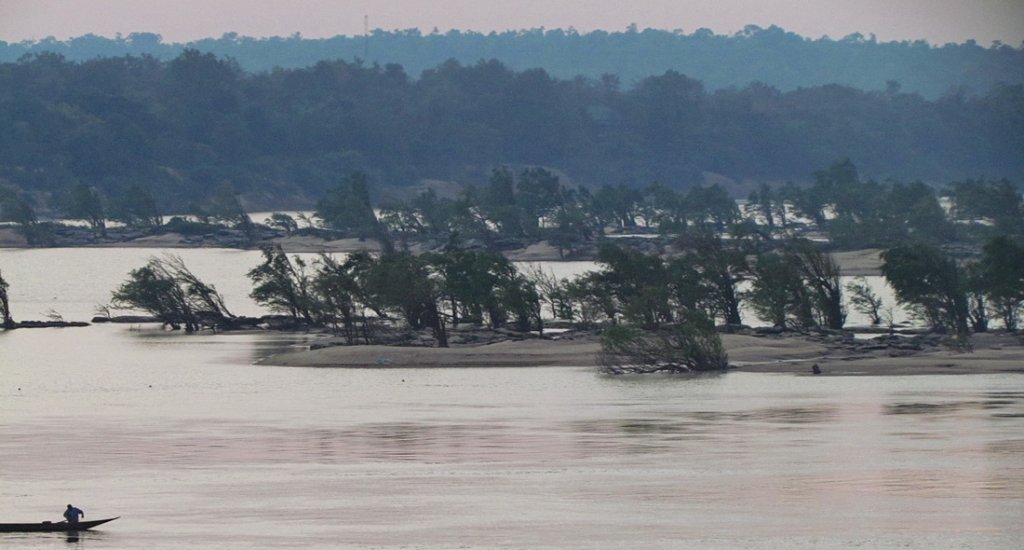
[0,50,1024,211]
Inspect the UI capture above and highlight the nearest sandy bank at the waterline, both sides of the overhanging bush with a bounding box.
[262,333,1024,376]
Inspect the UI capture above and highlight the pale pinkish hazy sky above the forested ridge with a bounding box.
[0,0,1024,46]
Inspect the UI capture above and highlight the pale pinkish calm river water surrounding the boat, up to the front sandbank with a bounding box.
[0,250,1024,549]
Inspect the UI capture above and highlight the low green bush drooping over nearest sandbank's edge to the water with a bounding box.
[600,315,729,374]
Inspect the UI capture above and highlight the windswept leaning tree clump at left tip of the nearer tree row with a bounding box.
[113,256,233,334]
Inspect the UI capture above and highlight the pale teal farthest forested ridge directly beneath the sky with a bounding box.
[0,26,1024,99]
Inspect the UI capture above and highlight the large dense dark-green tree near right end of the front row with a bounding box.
[882,244,969,336]
